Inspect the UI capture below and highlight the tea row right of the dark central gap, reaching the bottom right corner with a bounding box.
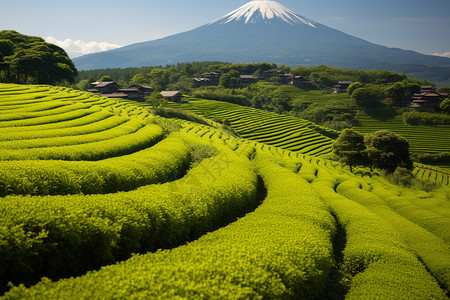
[312,177,446,299]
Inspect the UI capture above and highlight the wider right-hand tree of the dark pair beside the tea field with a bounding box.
[364,130,413,173]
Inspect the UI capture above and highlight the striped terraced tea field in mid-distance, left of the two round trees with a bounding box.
[170,98,334,156]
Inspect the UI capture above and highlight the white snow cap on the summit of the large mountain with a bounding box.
[213,0,317,28]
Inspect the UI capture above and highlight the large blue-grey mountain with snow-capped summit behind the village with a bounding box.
[74,1,450,77]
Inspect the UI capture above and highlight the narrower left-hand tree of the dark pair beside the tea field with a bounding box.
[333,129,367,172]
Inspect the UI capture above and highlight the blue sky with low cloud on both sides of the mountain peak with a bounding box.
[0,0,450,57]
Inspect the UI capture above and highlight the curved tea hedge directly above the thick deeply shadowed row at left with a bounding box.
[0,135,190,196]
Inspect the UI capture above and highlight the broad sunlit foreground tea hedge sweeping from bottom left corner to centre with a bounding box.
[2,159,335,299]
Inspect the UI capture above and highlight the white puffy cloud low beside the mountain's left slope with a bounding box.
[45,36,122,58]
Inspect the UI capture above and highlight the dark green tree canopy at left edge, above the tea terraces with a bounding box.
[0,30,78,84]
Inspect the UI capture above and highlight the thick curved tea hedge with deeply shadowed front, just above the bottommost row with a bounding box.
[0,148,258,288]
